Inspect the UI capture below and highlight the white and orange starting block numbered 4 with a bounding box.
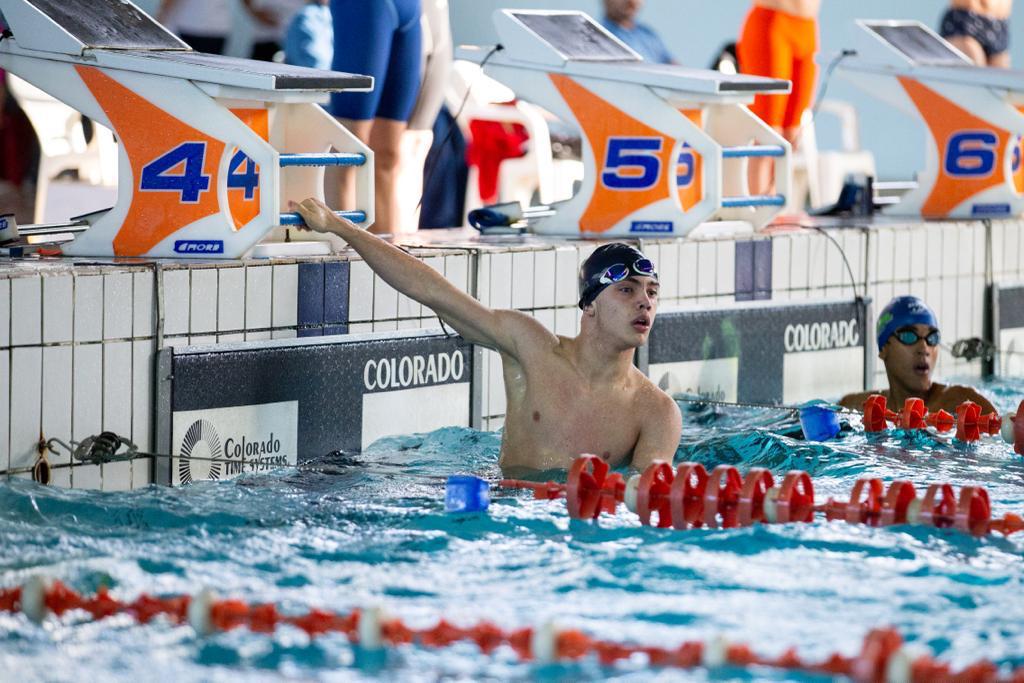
[0,0,374,258]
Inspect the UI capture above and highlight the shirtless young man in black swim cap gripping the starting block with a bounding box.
[297,199,682,474]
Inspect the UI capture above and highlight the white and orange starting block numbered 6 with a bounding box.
[839,20,1024,218]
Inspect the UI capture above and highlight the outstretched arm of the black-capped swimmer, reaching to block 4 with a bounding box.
[296,199,557,358]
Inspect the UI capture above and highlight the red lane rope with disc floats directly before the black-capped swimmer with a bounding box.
[501,456,1024,536]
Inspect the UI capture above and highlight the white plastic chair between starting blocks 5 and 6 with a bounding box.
[787,99,877,211]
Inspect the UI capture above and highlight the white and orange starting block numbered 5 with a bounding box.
[457,9,792,238]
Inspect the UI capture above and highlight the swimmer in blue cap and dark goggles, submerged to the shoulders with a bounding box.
[840,296,994,413]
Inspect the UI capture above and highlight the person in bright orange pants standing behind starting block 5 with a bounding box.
[736,0,821,195]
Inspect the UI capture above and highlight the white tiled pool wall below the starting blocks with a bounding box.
[0,216,1024,490]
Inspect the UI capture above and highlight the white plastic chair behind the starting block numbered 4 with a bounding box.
[7,73,118,223]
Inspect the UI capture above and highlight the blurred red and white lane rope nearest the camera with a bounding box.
[0,581,1024,683]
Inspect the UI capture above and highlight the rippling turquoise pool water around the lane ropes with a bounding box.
[0,381,1024,681]
